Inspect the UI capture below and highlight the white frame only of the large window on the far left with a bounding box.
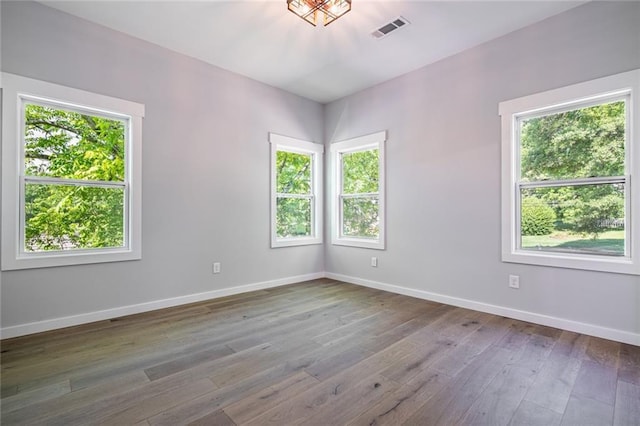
[1,73,144,270]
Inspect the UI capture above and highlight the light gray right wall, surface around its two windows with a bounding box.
[325,2,640,341]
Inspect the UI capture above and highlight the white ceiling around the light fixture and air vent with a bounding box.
[41,0,584,103]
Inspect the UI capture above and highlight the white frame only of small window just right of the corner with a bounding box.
[331,130,387,250]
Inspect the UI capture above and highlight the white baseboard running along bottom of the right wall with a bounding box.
[325,272,640,346]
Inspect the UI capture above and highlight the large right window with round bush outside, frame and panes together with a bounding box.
[500,70,640,274]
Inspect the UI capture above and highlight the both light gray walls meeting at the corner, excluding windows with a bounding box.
[0,1,640,342]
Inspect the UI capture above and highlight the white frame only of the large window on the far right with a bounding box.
[499,70,640,275]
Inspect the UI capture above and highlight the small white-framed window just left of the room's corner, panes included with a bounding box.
[269,133,324,247]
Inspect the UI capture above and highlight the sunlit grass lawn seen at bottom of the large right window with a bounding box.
[522,230,624,256]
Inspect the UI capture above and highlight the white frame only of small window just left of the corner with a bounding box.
[269,133,324,248]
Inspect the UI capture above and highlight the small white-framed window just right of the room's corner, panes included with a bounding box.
[331,132,386,250]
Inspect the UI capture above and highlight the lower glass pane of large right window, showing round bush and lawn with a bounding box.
[520,184,625,256]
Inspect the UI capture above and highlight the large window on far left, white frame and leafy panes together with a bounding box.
[2,73,144,270]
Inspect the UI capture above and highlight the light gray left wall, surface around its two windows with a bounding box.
[2,1,324,327]
